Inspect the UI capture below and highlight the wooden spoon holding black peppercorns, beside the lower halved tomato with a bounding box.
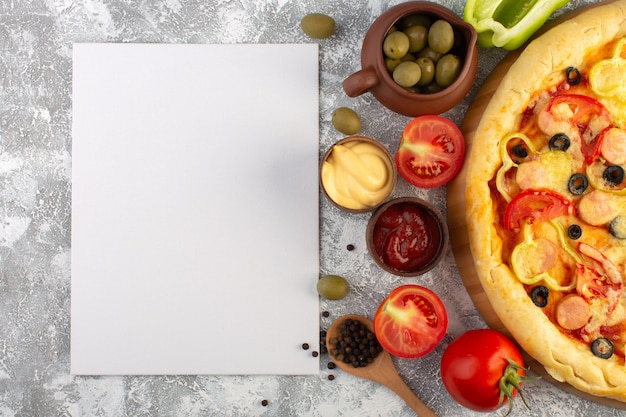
[326,314,437,417]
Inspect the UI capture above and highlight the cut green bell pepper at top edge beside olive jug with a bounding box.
[463,0,569,51]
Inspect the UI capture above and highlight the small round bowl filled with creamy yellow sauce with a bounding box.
[320,135,398,213]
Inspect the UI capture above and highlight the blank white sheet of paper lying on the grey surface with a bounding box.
[71,44,319,375]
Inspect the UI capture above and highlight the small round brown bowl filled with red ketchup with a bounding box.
[365,197,449,277]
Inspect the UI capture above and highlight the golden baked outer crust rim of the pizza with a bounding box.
[465,0,626,401]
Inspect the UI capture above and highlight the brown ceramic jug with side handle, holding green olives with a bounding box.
[343,1,478,117]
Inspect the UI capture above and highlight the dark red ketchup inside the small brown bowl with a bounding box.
[373,203,441,272]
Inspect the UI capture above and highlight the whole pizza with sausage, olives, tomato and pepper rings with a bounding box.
[465,0,626,401]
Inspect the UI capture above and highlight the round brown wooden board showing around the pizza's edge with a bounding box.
[447,1,626,409]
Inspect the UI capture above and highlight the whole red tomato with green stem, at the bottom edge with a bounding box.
[441,329,537,415]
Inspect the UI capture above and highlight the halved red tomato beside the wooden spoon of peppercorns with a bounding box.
[374,284,448,358]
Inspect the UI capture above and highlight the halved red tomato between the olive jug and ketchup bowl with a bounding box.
[396,115,465,188]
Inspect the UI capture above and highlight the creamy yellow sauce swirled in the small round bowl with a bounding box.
[321,140,394,210]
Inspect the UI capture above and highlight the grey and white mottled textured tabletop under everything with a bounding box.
[0,0,624,417]
